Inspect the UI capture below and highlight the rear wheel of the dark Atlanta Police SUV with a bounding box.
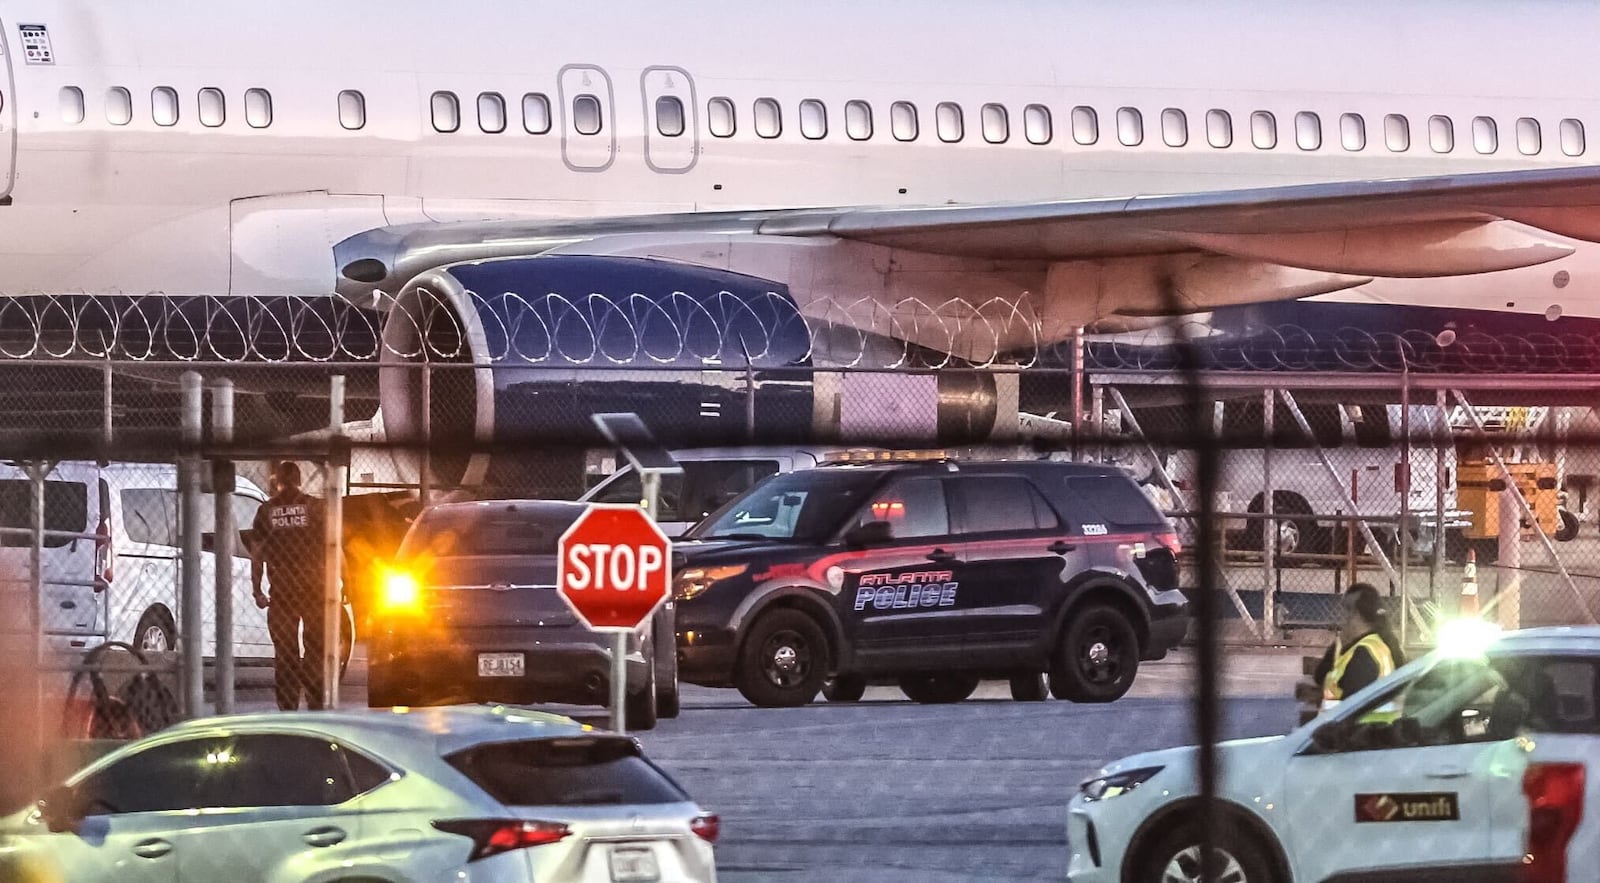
[1050,603,1139,702]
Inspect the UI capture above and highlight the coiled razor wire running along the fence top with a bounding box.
[0,290,1600,374]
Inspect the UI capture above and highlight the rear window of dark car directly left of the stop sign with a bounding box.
[400,505,582,558]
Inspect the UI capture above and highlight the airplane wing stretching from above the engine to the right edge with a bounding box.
[334,166,1600,296]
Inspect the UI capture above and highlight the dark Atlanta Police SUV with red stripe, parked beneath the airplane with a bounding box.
[674,451,1189,707]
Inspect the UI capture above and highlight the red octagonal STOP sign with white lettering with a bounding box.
[555,505,672,630]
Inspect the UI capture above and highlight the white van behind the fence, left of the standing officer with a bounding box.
[0,462,354,662]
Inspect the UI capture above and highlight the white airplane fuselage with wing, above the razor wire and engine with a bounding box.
[0,0,1600,467]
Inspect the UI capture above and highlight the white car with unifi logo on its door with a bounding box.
[1067,619,1600,883]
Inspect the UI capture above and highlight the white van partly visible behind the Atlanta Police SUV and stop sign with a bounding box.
[581,446,862,536]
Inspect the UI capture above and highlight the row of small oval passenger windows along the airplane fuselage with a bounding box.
[61,86,1587,157]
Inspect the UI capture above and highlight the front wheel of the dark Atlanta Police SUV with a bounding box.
[733,609,829,709]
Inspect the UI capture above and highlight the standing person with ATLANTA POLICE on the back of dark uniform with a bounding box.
[250,461,326,712]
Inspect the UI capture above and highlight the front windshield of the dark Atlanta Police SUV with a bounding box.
[688,467,883,542]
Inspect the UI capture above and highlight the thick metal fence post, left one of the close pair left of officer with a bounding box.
[178,371,205,718]
